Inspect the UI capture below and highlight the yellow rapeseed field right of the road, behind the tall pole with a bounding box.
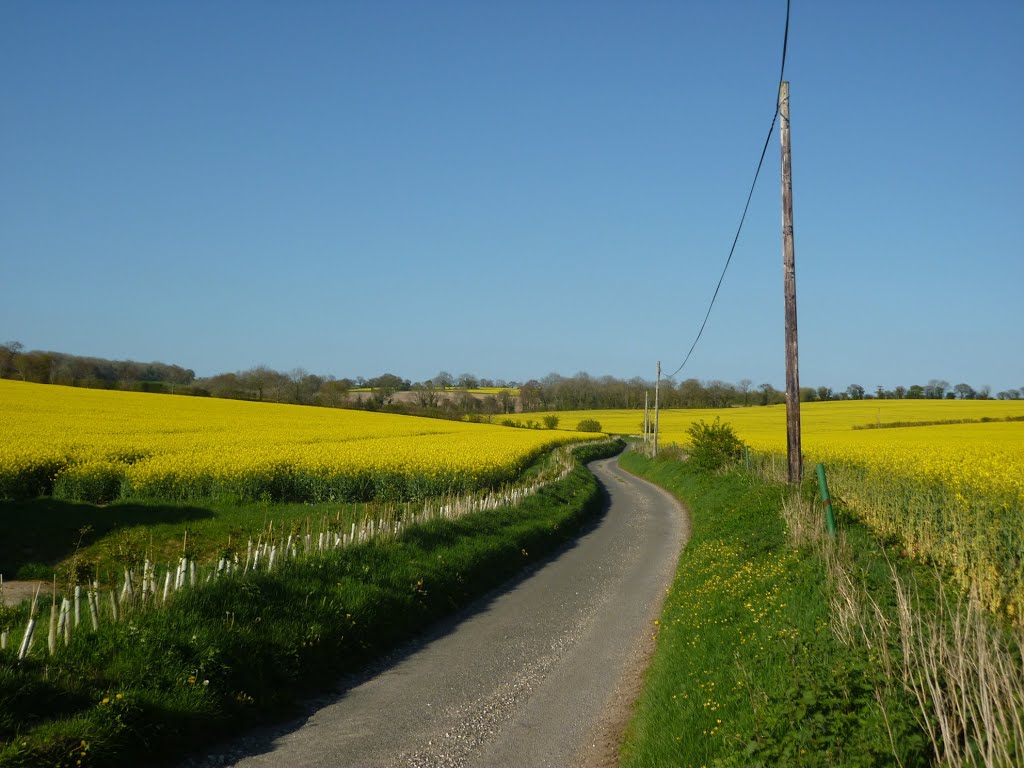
[531,400,1024,623]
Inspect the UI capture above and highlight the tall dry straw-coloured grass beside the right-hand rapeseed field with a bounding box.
[782,494,1024,768]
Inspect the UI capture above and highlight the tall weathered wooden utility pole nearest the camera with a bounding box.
[778,80,804,483]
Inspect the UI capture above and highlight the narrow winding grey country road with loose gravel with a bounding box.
[188,459,688,768]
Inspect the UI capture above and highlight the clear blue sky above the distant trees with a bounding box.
[0,0,1024,392]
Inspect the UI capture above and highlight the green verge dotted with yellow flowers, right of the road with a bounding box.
[622,453,932,768]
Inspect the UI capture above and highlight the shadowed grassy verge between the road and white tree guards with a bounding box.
[0,443,617,766]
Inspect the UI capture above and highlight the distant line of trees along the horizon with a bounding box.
[6,341,1024,420]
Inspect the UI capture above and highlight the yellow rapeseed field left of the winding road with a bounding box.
[0,381,594,501]
